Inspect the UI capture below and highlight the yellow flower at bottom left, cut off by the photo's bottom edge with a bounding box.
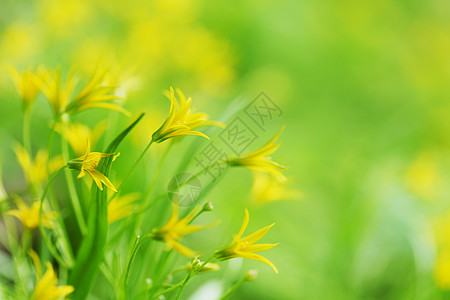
[30,258,74,300]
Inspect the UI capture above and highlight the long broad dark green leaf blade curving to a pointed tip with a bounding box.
[69,113,144,299]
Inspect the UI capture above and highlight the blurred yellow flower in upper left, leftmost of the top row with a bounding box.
[8,67,39,110]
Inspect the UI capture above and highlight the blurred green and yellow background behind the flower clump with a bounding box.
[0,0,450,299]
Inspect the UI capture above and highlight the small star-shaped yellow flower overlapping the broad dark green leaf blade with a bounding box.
[67,140,117,192]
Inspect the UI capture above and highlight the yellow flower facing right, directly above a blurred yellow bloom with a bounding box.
[228,127,287,181]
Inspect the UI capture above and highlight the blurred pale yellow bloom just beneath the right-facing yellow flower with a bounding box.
[251,172,301,204]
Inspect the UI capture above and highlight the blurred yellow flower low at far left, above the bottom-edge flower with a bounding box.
[7,195,56,229]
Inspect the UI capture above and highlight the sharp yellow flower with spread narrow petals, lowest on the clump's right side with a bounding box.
[214,209,278,274]
